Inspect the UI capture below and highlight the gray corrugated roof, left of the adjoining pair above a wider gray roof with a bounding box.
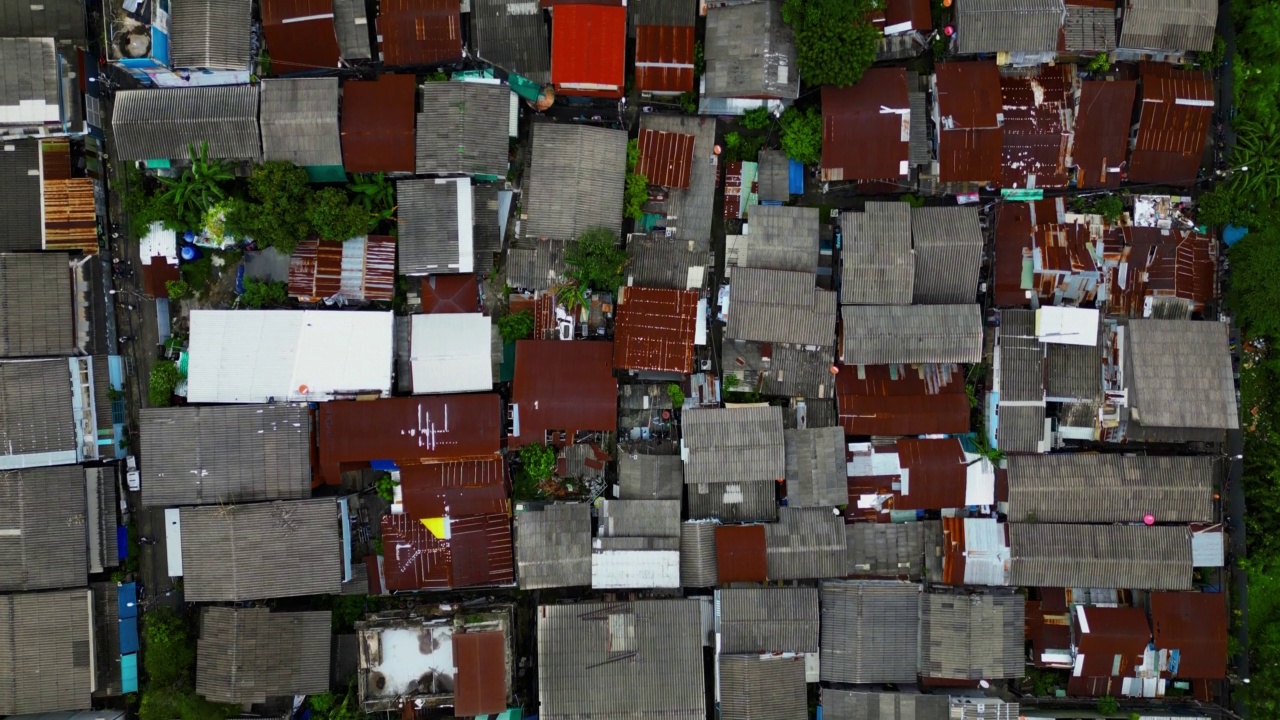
[840,201,915,305]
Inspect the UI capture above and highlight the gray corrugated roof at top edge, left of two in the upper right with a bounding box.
[956,0,1065,55]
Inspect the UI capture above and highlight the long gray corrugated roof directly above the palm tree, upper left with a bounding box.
[111,85,262,161]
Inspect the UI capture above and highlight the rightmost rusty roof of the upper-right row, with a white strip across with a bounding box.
[1129,63,1213,184]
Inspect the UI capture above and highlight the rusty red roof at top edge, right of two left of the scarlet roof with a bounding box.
[378,0,462,67]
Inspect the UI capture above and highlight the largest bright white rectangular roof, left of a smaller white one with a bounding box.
[187,310,391,402]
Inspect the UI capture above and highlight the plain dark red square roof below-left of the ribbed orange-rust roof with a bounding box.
[507,340,618,448]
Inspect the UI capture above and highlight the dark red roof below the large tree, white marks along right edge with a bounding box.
[822,68,911,181]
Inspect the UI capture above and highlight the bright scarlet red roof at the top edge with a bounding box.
[552,5,627,97]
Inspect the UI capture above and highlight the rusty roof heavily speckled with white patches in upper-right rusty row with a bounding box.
[1000,65,1075,188]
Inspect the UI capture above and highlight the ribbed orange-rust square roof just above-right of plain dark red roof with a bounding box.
[613,287,699,374]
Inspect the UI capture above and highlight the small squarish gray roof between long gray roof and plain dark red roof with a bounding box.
[262,78,342,167]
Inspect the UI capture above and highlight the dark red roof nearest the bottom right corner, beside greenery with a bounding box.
[1151,592,1229,680]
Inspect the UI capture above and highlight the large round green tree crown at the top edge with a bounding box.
[782,0,881,87]
